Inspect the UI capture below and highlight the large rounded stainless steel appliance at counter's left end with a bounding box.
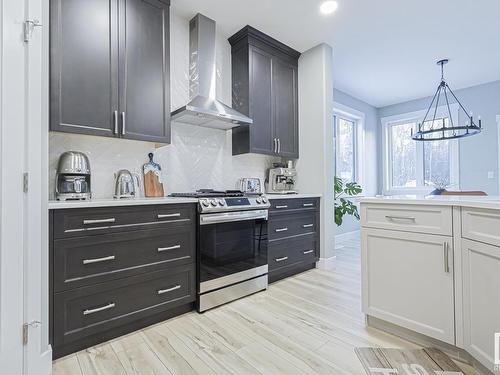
[56,151,92,200]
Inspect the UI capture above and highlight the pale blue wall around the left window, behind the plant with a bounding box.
[333,89,379,235]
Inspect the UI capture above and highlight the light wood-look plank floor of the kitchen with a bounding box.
[53,240,478,375]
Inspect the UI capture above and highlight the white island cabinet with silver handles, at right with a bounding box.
[361,197,500,372]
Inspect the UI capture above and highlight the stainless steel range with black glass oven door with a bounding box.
[172,190,270,312]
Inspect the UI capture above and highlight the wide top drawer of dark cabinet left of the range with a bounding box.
[54,204,196,238]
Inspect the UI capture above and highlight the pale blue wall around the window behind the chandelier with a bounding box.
[378,81,500,195]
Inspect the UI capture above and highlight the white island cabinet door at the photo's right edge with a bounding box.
[462,239,500,371]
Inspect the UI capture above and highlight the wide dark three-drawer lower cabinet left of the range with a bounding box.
[49,204,196,358]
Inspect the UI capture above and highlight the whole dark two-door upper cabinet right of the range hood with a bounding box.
[229,26,300,158]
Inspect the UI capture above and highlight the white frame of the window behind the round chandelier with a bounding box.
[381,103,460,195]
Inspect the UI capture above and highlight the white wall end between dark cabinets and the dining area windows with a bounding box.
[296,44,335,264]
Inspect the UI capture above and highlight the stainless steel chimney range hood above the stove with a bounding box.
[172,13,253,130]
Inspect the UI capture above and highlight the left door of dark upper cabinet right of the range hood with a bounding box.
[249,47,275,154]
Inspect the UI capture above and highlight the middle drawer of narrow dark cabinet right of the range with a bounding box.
[268,211,318,241]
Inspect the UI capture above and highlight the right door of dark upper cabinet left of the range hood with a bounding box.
[119,0,170,143]
